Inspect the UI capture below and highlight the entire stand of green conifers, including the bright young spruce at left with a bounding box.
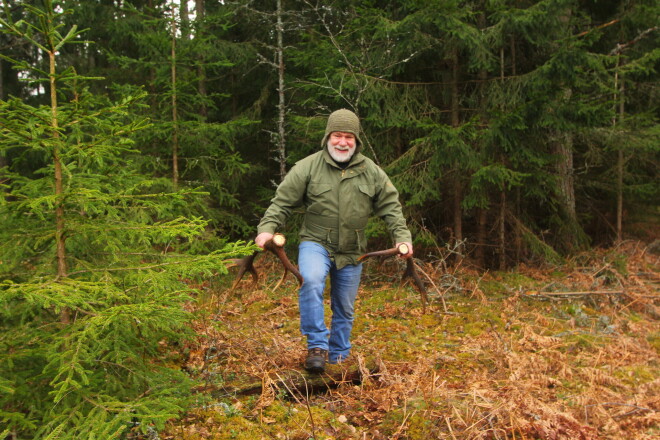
[0,0,660,438]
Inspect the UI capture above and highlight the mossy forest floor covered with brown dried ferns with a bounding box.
[160,242,660,440]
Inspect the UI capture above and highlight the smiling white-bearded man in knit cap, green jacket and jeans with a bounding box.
[255,109,412,373]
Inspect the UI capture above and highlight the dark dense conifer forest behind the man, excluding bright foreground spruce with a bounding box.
[0,0,659,267]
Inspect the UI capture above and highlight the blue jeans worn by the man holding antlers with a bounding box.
[298,241,362,363]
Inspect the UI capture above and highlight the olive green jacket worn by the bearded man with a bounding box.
[257,148,412,269]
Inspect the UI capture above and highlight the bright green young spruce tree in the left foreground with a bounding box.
[0,0,251,439]
